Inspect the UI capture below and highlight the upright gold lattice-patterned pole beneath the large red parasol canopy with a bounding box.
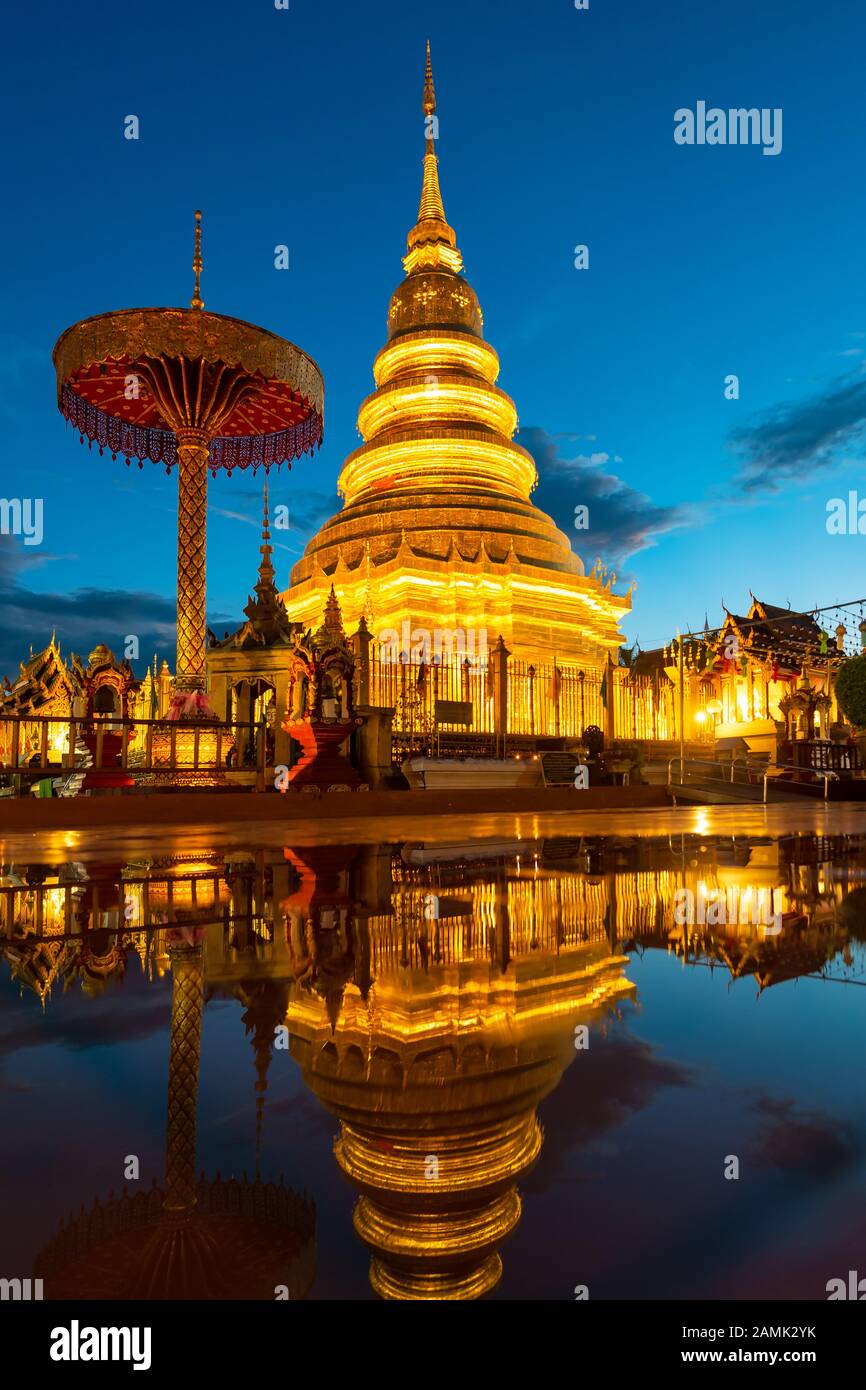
[175,428,209,691]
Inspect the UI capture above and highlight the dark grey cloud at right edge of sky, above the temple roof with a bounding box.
[728,374,866,492]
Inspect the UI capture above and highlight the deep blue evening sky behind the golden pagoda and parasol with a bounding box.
[0,0,866,673]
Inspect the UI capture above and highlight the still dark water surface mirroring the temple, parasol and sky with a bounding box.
[0,817,866,1300]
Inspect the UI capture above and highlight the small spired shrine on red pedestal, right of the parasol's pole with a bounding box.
[281,585,363,791]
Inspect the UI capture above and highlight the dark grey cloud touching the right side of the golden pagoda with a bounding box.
[520,427,696,564]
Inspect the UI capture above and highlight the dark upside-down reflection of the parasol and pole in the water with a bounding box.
[35,913,316,1300]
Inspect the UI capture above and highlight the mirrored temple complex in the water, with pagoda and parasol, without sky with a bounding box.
[0,835,866,1300]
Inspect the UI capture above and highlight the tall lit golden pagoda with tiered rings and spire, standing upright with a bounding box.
[284,43,631,669]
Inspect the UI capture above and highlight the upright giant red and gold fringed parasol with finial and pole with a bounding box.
[54,213,324,706]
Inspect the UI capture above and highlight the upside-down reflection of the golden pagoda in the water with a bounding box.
[288,850,632,1300]
